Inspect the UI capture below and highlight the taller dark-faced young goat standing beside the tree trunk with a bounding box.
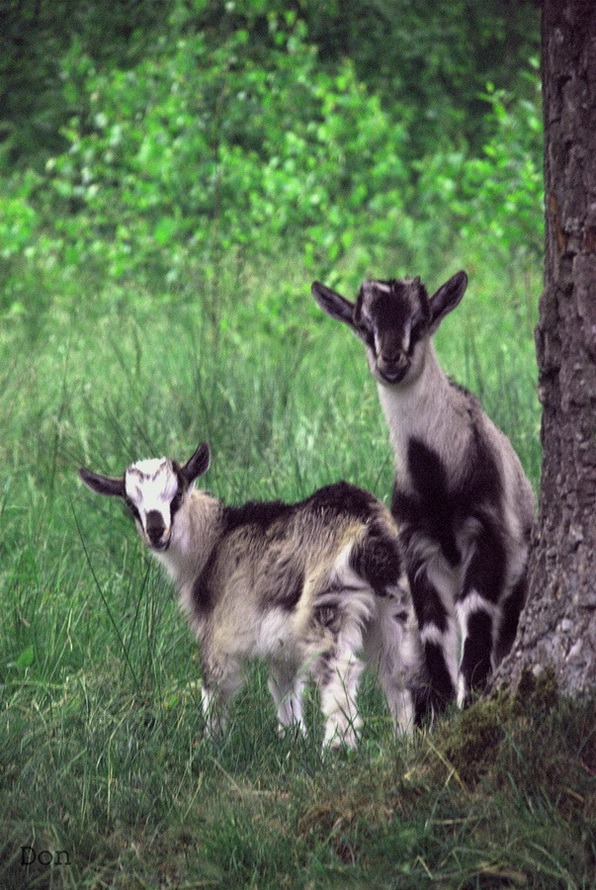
[312,272,534,709]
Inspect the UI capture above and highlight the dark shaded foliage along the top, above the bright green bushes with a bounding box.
[0,0,539,170]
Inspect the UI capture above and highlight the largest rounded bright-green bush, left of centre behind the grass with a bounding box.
[33,14,408,282]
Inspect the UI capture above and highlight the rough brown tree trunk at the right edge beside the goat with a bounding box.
[493,0,596,696]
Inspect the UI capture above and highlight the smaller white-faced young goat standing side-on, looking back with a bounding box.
[79,444,421,747]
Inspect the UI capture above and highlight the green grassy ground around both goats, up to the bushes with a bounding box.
[0,250,596,890]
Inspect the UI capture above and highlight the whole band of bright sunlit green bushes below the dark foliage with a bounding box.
[0,2,542,335]
